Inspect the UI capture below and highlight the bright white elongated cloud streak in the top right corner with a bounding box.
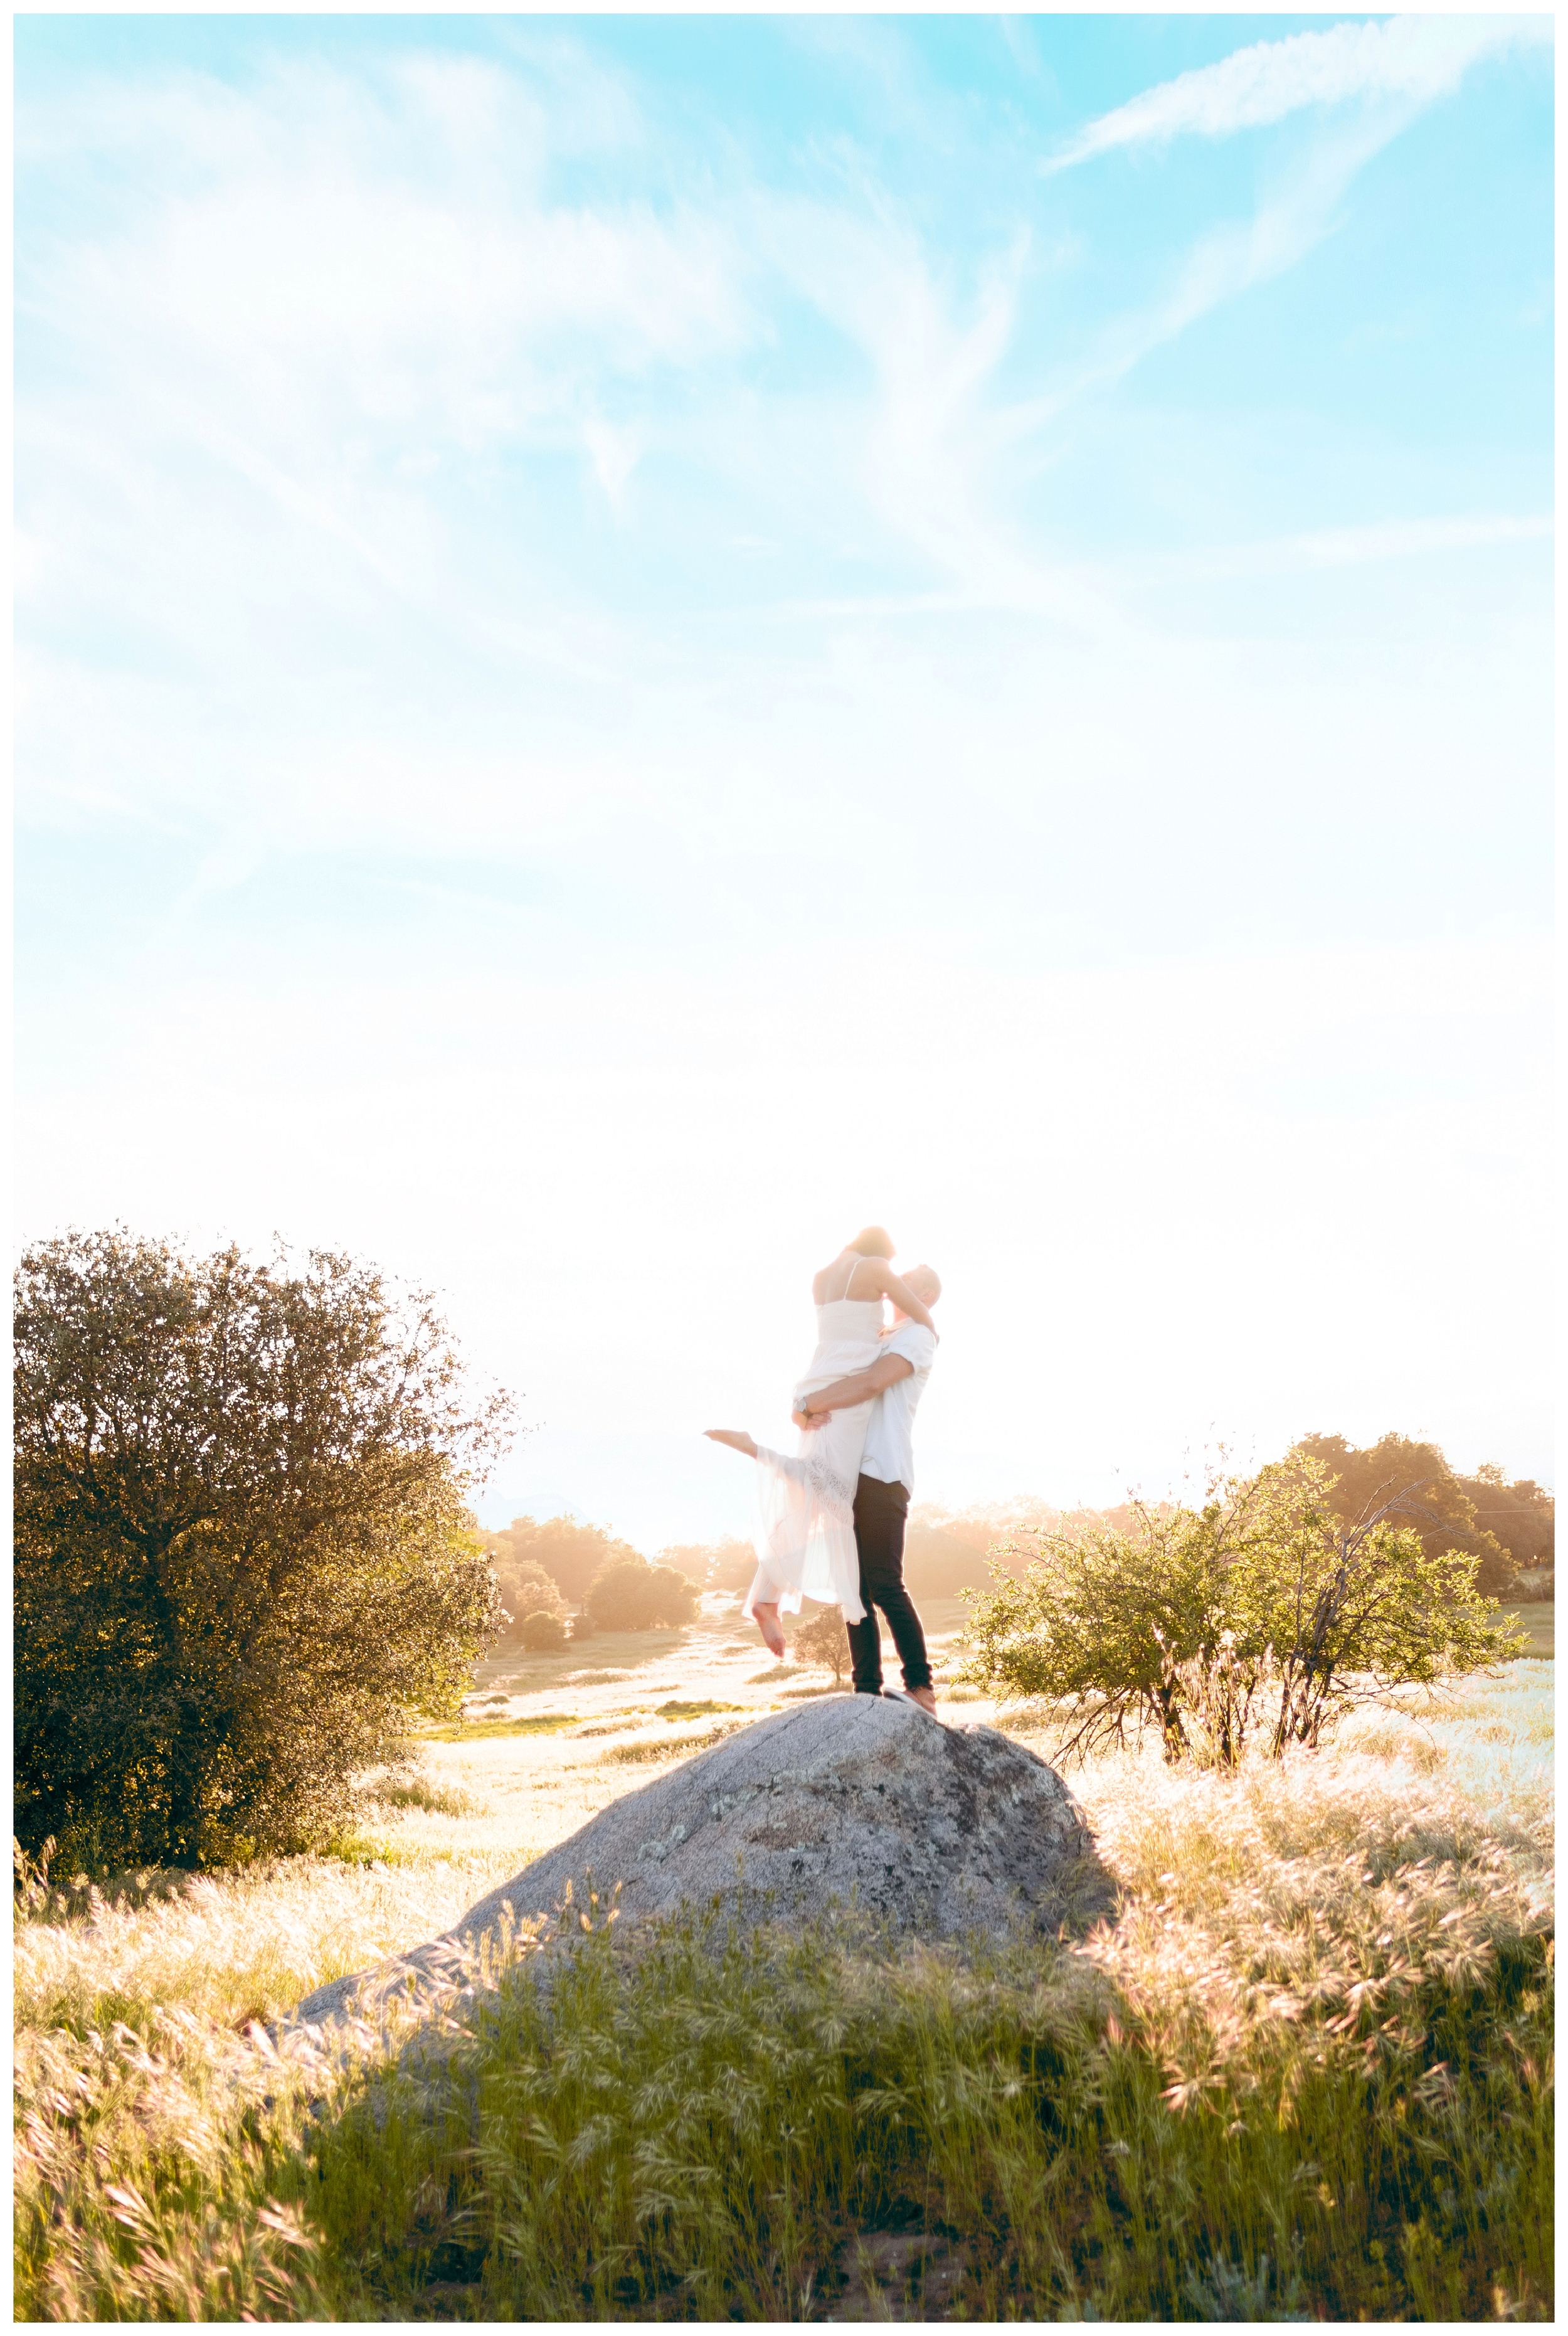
[1044,16,1552,171]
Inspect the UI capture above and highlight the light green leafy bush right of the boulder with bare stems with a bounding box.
[965,1460,1512,1764]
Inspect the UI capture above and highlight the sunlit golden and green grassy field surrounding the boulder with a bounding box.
[16,1600,1552,2320]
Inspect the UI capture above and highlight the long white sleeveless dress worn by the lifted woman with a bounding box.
[741,1266,883,1621]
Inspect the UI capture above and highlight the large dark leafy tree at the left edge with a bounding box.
[14,1231,507,1869]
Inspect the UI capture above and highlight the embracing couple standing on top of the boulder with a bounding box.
[708,1224,941,1712]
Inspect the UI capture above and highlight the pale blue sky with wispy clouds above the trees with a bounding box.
[16,16,1552,1546]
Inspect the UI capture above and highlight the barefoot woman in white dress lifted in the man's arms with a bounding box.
[708,1224,937,1654]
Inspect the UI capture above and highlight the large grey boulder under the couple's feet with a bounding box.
[294,1696,1108,2020]
